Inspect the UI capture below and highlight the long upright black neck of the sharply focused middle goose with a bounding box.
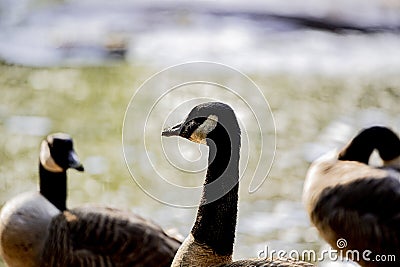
[192,125,240,255]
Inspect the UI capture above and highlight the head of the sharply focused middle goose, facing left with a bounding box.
[162,102,240,145]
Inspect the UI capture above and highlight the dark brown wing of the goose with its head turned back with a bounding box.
[311,177,400,266]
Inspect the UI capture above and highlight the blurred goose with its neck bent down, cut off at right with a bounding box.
[303,126,400,266]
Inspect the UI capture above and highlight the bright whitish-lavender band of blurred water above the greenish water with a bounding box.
[0,0,400,75]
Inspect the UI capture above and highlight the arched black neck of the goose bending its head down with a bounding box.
[339,126,400,164]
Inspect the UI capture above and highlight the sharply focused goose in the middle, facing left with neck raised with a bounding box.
[162,102,313,267]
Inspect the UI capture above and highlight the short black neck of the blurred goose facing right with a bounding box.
[39,163,67,211]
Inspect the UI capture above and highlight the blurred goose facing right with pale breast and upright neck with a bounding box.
[0,133,180,267]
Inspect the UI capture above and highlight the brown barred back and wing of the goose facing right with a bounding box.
[42,206,180,267]
